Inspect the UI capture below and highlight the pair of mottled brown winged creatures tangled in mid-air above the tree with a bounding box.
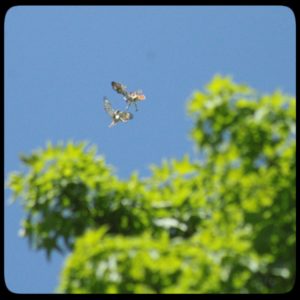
[103,81,146,127]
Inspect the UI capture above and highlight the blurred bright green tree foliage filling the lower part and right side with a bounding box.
[8,75,296,293]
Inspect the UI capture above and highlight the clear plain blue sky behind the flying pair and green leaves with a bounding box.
[3,6,296,293]
